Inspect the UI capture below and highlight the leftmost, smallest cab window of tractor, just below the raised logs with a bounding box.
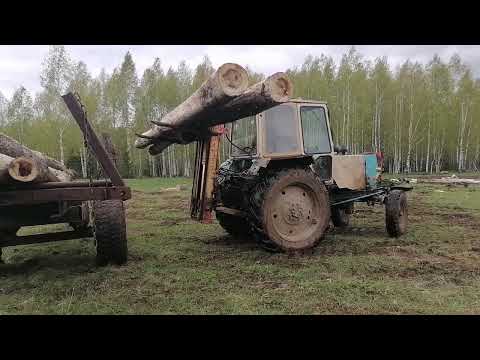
[232,116,257,156]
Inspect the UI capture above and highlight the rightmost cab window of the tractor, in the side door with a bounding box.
[300,106,331,154]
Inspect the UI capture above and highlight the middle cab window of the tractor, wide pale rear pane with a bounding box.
[264,104,299,154]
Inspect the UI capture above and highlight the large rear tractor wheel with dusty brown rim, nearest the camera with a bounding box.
[258,169,330,251]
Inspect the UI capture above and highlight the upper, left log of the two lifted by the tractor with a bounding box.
[135,63,248,149]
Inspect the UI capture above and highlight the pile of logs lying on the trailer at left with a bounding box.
[0,133,75,185]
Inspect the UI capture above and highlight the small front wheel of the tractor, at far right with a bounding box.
[385,190,408,237]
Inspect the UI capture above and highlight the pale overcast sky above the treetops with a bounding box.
[0,45,480,99]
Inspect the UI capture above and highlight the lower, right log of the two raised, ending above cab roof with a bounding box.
[145,73,293,155]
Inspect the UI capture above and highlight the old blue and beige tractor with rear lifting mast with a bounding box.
[191,99,411,252]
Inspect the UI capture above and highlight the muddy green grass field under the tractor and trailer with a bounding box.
[0,175,480,314]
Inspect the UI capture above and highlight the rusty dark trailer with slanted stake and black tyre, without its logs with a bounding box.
[0,93,131,266]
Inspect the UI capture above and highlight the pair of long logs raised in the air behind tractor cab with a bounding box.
[135,63,293,155]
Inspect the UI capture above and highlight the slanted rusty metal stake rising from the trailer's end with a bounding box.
[62,93,125,186]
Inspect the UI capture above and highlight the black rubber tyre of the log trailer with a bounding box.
[93,200,128,266]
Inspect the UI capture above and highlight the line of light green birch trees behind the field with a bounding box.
[0,46,480,177]
